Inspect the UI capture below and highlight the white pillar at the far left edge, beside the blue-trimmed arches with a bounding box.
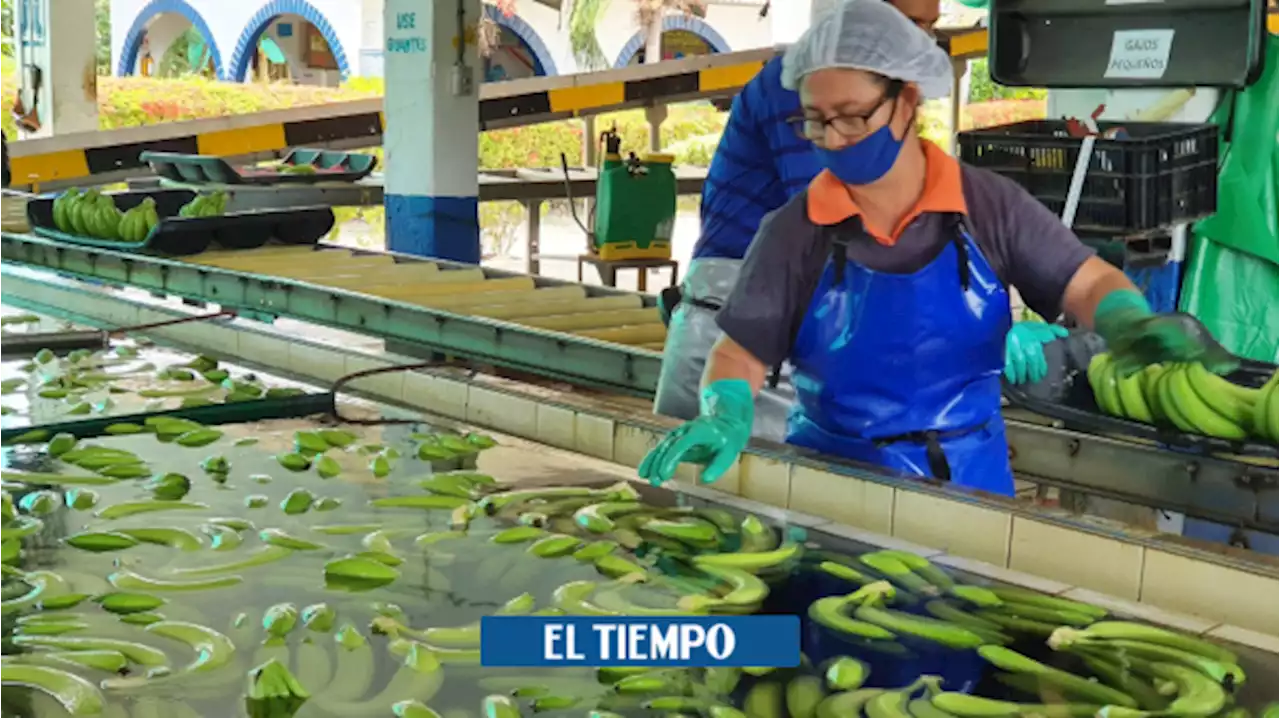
[13,0,97,138]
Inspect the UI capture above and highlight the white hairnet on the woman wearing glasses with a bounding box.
[782,0,951,99]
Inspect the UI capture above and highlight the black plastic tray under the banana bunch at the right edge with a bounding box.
[1004,331,1280,459]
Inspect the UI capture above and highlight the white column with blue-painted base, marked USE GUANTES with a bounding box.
[383,0,481,264]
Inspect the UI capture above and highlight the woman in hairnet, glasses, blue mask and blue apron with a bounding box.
[640,0,1223,495]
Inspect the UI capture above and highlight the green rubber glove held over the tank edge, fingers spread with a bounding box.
[640,379,755,486]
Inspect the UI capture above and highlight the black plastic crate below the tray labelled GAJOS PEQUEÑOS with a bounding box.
[959,120,1219,235]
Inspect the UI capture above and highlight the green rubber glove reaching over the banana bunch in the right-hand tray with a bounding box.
[1093,289,1240,376]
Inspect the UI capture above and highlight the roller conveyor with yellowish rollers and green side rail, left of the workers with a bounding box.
[0,234,666,395]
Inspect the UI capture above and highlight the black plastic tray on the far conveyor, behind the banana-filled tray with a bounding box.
[138,147,378,184]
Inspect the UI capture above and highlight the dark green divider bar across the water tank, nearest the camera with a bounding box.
[0,392,337,445]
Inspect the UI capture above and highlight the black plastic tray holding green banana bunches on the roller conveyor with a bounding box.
[27,189,334,256]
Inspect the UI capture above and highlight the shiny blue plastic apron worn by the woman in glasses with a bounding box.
[787,218,1014,495]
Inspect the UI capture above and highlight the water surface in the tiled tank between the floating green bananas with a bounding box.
[0,335,1280,718]
